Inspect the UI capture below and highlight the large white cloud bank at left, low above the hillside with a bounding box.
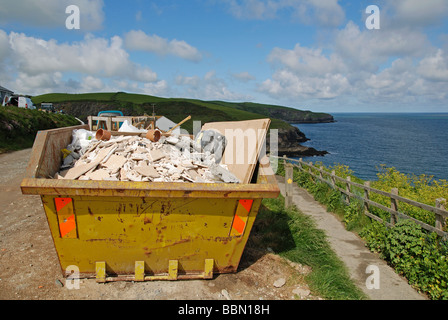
[0,30,157,94]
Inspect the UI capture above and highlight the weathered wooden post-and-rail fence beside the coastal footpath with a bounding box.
[271,156,448,237]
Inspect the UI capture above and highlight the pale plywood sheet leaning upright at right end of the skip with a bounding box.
[202,119,271,183]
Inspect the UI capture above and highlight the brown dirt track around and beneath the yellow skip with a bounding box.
[0,150,319,300]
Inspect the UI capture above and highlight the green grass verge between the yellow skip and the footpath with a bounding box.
[250,195,368,300]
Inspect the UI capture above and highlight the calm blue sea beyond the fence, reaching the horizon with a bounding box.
[295,113,448,181]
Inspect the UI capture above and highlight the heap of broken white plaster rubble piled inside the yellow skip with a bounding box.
[54,129,240,183]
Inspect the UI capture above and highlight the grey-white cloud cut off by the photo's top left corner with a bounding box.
[0,0,104,31]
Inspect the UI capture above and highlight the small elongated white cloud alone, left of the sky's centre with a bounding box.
[125,30,202,62]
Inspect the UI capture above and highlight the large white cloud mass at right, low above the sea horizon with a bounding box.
[258,18,448,109]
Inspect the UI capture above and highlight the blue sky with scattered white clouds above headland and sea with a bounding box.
[0,0,448,113]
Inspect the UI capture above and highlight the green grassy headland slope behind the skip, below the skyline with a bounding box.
[33,92,326,130]
